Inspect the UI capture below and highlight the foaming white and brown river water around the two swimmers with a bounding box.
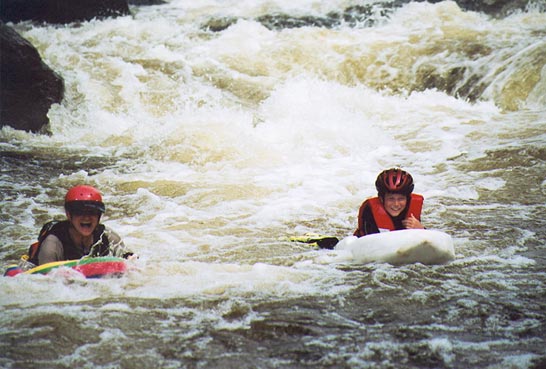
[0,0,546,369]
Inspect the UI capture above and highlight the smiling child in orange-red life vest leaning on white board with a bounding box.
[354,168,425,237]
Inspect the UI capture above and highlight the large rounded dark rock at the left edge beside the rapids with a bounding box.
[0,22,64,132]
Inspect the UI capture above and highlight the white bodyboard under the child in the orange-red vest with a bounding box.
[335,229,455,265]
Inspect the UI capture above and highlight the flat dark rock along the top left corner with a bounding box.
[0,0,129,24]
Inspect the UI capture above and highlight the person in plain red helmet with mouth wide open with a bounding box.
[31,185,137,265]
